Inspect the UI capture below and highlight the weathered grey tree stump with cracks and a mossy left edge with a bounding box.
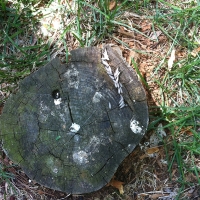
[0,46,148,194]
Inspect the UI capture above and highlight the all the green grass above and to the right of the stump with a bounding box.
[0,0,200,198]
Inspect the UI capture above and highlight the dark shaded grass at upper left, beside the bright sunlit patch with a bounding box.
[0,1,49,99]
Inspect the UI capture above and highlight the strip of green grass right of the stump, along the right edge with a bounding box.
[150,1,200,191]
